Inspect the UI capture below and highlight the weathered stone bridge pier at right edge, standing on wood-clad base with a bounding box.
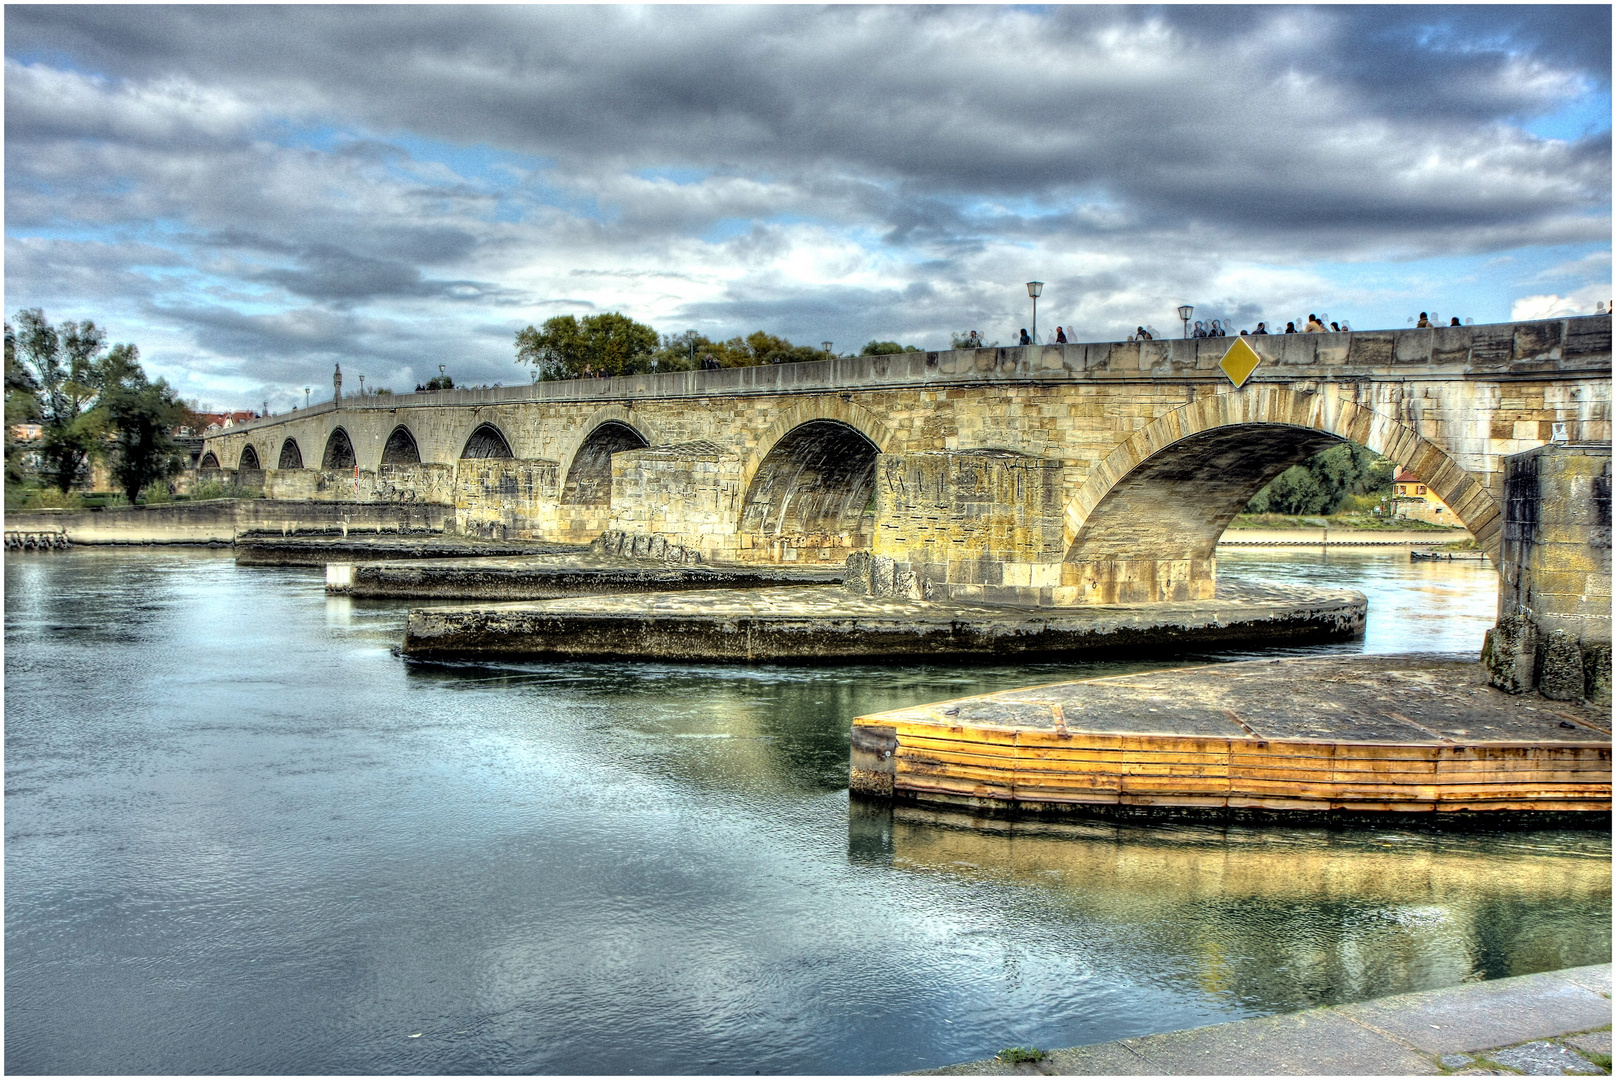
[1482,445,1611,705]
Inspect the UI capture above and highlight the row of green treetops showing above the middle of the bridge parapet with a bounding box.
[516,312,918,382]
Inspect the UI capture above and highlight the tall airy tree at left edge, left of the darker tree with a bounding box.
[6,307,117,491]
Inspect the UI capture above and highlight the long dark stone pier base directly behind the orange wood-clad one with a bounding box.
[402,582,1367,663]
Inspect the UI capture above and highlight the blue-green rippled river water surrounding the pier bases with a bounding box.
[5,548,1611,1074]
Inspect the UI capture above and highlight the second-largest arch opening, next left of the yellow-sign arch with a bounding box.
[740,419,881,561]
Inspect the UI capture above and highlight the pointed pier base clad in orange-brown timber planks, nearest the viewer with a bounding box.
[850,656,1611,821]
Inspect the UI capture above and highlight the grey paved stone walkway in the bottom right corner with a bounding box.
[918,964,1611,1077]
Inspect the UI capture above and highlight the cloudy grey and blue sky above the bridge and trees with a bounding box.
[5,5,1611,412]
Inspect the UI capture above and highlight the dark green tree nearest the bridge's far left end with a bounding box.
[100,344,191,503]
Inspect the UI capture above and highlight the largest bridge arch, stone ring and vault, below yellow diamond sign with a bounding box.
[1062,386,1501,601]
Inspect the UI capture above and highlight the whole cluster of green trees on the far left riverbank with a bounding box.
[5,307,192,503]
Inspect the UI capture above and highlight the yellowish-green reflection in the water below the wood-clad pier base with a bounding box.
[848,800,1611,1010]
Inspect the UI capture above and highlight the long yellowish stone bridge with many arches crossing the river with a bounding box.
[202,315,1611,605]
